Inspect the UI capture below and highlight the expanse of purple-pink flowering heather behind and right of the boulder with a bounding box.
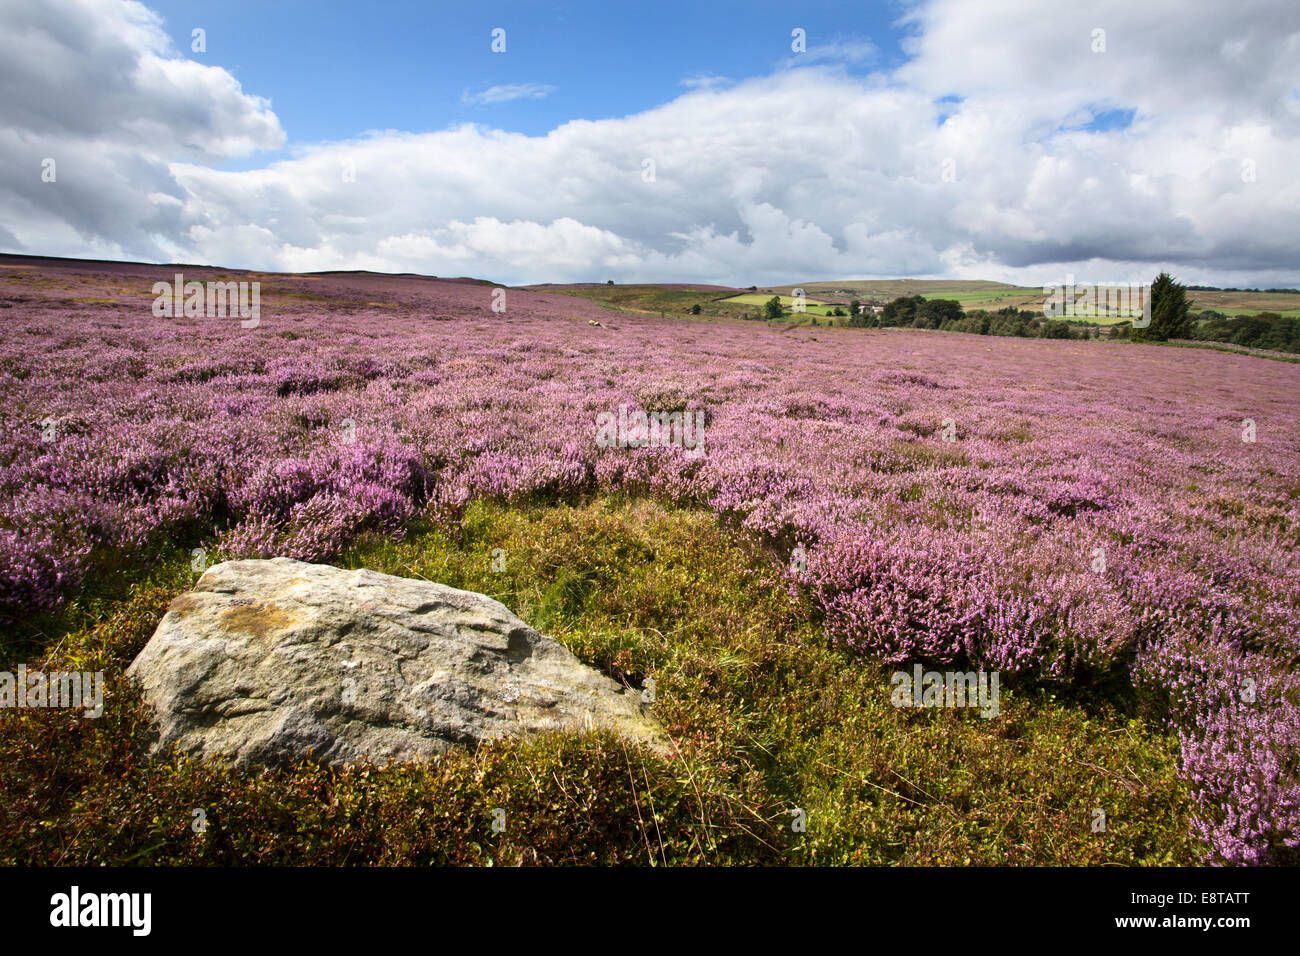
[0,265,1300,862]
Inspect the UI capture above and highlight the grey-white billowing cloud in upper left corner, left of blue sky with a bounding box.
[0,0,285,258]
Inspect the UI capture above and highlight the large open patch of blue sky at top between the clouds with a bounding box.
[150,0,906,162]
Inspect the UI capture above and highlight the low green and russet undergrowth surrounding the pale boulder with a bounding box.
[0,498,1197,865]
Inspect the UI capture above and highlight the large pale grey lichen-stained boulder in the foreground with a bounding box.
[127,558,667,766]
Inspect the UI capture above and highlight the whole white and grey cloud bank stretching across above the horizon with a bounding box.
[0,0,1300,285]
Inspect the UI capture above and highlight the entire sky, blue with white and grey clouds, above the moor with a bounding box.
[0,0,1300,287]
